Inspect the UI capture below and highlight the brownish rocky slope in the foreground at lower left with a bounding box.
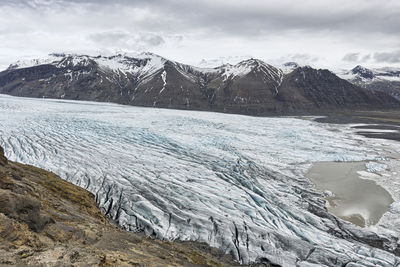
[0,148,244,266]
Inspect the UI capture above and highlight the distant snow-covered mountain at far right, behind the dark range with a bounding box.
[337,65,400,100]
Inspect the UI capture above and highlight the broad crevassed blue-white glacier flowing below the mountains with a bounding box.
[0,95,400,267]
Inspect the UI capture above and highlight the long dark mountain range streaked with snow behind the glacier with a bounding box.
[0,53,400,115]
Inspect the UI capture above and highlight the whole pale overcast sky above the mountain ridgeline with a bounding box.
[0,0,400,69]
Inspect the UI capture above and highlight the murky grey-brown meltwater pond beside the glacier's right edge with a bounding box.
[306,162,393,227]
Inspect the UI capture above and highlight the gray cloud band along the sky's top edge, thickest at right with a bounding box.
[0,0,400,35]
